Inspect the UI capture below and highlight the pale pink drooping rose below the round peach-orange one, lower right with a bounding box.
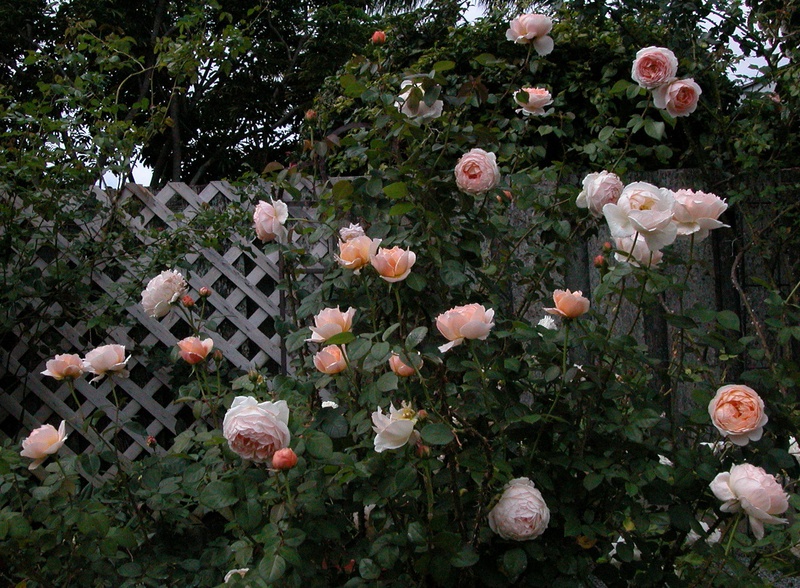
[709,463,789,539]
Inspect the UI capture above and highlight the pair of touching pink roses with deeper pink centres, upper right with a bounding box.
[631,47,702,116]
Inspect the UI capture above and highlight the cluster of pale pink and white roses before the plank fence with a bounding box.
[576,171,728,266]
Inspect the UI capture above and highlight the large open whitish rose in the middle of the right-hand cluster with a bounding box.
[603,182,678,251]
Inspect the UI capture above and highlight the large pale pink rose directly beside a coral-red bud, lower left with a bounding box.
[222,396,292,463]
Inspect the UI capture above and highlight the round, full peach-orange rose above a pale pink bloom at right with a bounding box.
[708,384,769,445]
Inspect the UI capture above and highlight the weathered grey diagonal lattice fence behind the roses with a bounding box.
[0,182,327,478]
